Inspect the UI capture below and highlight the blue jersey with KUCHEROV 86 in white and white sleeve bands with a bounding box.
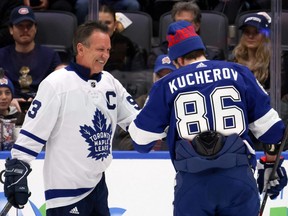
[129,61,285,164]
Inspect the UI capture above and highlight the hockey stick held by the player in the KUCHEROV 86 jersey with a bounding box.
[259,126,288,216]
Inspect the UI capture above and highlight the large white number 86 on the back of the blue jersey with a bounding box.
[174,86,245,140]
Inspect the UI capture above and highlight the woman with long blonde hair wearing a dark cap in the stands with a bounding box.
[232,12,271,89]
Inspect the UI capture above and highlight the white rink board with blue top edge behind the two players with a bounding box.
[0,151,288,216]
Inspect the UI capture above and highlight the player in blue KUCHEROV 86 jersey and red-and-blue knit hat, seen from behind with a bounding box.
[128,21,287,216]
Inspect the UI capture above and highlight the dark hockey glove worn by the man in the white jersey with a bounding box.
[4,158,31,209]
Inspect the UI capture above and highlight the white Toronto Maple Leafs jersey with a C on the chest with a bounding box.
[12,63,139,209]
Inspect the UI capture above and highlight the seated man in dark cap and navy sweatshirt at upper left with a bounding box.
[0,6,61,108]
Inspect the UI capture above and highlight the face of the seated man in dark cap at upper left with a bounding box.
[9,20,37,45]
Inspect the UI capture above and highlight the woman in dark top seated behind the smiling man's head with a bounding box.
[99,4,146,72]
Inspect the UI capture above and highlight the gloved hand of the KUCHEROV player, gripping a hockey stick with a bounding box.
[257,156,287,199]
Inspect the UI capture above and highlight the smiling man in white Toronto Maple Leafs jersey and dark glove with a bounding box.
[4,22,139,216]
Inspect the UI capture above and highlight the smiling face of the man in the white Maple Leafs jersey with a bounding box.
[76,30,111,75]
